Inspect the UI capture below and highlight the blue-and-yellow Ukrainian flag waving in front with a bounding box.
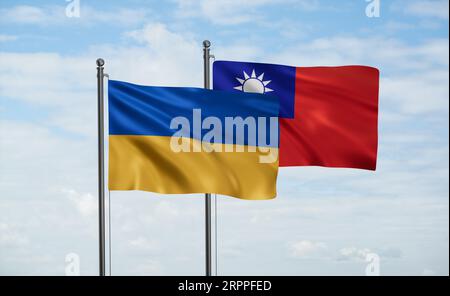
[108,80,279,199]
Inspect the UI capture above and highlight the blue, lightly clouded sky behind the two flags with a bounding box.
[0,0,449,275]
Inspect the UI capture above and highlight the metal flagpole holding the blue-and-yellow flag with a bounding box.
[96,59,106,276]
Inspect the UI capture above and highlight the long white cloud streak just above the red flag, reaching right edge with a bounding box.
[270,36,449,70]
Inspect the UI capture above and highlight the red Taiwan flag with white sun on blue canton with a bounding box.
[213,61,379,170]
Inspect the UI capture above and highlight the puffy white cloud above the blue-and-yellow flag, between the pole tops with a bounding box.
[103,23,203,87]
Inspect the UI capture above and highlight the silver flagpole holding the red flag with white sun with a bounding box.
[203,40,212,276]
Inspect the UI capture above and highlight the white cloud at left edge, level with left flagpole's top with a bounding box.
[0,52,95,107]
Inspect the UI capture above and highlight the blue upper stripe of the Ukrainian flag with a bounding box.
[108,80,279,146]
